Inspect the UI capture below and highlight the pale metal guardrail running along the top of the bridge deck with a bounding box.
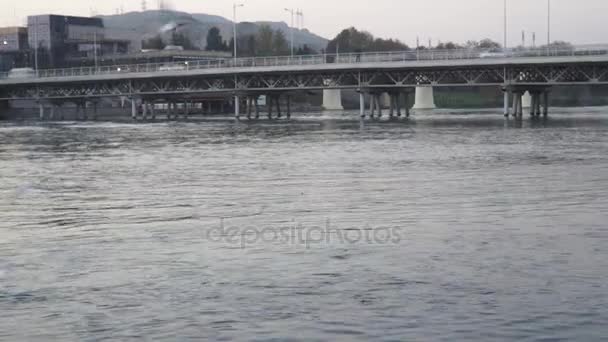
[0,45,608,79]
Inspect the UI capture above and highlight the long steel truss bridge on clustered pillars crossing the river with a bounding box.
[0,45,608,119]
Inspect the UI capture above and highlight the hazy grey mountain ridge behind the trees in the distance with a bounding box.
[100,10,328,51]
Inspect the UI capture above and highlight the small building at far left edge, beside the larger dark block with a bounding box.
[0,27,29,72]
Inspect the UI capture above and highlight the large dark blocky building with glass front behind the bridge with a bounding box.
[27,14,130,68]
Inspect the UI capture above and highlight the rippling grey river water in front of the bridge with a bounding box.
[0,108,608,341]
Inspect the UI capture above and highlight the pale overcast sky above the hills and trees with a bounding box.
[0,0,608,45]
